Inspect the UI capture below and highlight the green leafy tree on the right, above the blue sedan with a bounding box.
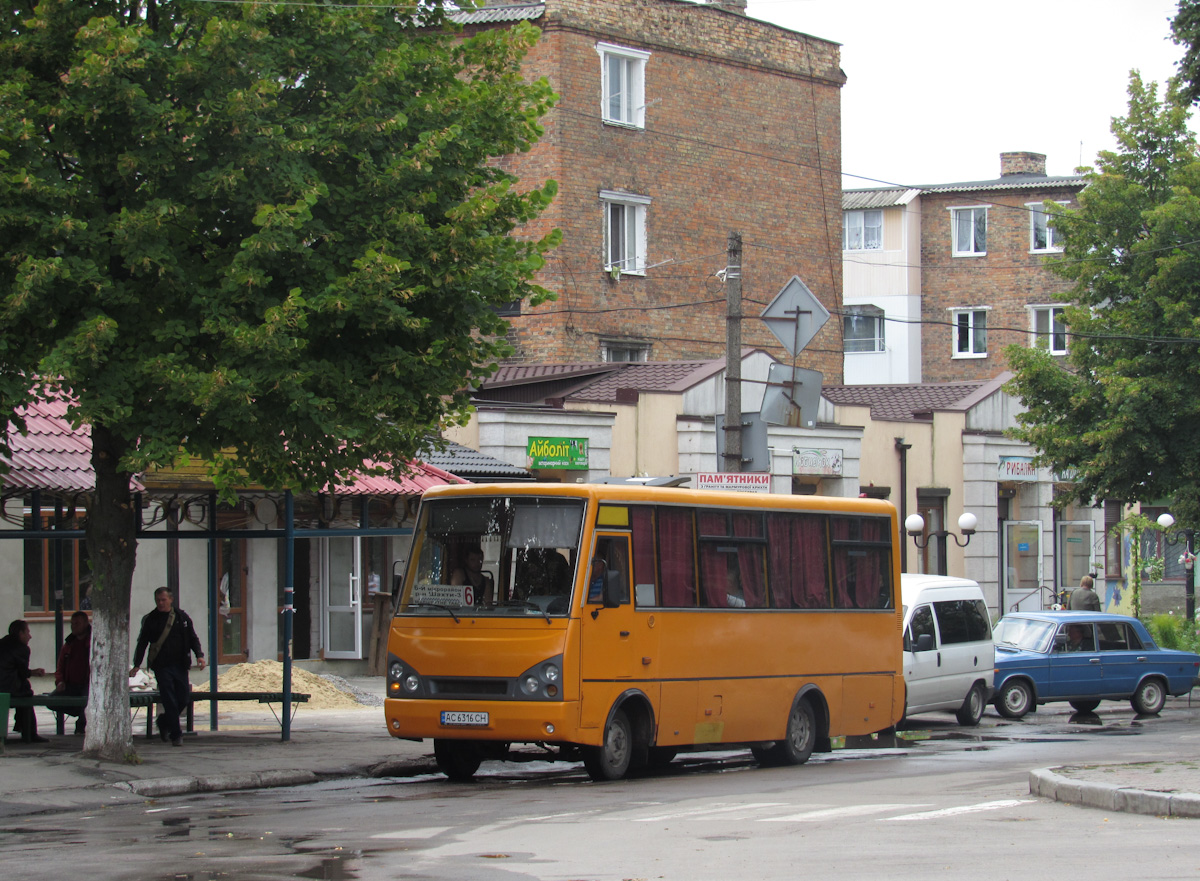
[1006,73,1200,523]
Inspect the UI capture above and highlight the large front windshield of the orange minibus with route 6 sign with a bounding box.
[397,496,584,618]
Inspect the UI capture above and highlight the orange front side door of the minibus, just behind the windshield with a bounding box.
[580,533,649,727]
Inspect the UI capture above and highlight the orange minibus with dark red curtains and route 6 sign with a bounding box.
[384,484,905,780]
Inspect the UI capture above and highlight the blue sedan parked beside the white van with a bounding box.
[992,612,1200,719]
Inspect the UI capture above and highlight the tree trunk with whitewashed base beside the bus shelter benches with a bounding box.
[83,425,137,762]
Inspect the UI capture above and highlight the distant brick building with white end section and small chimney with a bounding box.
[842,152,1084,383]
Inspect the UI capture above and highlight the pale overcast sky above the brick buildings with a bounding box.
[746,0,1195,187]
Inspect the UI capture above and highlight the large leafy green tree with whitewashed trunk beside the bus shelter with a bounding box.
[0,0,557,760]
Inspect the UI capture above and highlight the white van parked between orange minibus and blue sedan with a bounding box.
[900,575,996,725]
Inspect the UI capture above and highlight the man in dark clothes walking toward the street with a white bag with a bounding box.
[130,587,204,747]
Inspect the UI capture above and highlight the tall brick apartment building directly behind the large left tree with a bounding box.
[457,0,845,382]
